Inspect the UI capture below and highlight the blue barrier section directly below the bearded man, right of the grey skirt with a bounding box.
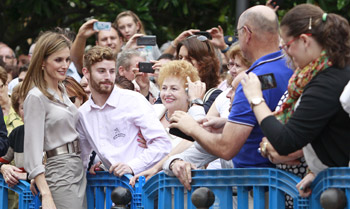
[86,171,145,209]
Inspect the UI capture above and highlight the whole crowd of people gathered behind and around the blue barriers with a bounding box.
[0,1,350,209]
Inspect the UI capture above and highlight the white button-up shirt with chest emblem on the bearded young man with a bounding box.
[77,88,171,174]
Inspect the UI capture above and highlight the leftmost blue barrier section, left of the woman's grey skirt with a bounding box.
[0,174,38,209]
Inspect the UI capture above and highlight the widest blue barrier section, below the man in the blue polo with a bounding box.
[142,168,309,209]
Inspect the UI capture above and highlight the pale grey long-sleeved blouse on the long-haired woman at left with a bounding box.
[23,86,79,179]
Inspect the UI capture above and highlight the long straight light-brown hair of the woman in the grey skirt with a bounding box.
[20,31,71,100]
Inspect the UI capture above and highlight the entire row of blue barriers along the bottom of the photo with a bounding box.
[0,168,350,209]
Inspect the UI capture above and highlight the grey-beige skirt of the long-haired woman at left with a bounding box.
[45,153,87,209]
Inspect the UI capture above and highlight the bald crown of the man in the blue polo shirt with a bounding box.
[238,5,279,38]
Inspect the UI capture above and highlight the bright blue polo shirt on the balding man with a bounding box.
[228,51,293,168]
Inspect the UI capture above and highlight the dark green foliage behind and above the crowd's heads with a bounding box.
[0,0,350,53]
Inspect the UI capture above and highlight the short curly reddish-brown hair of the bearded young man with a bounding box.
[84,46,116,72]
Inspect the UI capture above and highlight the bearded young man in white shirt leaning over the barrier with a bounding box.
[77,46,171,177]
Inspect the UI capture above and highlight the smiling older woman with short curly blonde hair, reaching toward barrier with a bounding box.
[130,60,200,185]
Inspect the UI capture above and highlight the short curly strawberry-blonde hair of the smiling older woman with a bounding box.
[158,60,200,88]
